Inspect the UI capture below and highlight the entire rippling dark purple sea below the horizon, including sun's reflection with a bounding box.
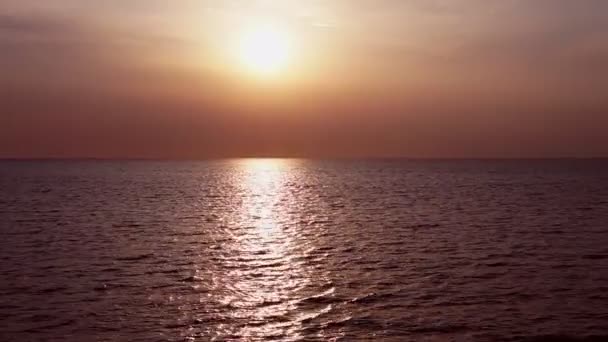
[0,160,608,341]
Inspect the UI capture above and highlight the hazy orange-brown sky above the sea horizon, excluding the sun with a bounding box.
[0,0,608,159]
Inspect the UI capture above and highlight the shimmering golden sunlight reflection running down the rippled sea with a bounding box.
[208,159,334,340]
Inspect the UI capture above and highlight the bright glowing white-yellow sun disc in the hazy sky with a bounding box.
[239,26,291,75]
